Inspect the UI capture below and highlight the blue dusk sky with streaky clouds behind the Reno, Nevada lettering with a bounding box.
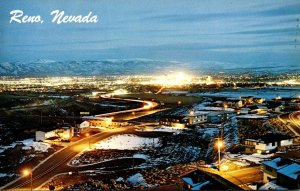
[0,0,300,66]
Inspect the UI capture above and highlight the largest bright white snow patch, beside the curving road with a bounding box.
[94,134,159,150]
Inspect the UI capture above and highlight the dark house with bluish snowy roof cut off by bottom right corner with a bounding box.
[277,163,300,189]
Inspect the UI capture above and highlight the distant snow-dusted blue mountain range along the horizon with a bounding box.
[0,59,300,76]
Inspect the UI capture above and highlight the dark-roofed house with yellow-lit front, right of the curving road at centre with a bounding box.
[159,115,188,128]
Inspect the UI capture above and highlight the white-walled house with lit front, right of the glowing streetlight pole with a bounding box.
[245,133,293,154]
